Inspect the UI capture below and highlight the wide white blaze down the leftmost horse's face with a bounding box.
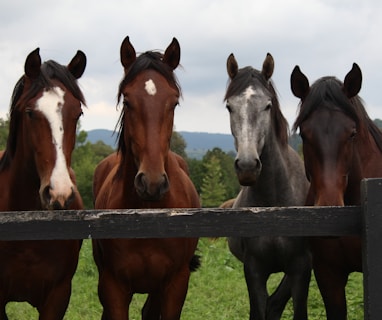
[36,87,73,194]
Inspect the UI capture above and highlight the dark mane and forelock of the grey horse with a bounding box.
[224,67,289,147]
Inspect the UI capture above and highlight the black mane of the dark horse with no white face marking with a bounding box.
[292,77,382,152]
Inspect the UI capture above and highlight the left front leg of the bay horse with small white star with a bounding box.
[98,270,133,320]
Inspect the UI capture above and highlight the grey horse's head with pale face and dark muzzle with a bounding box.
[225,53,286,186]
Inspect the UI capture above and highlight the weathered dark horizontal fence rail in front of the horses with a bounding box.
[0,206,362,240]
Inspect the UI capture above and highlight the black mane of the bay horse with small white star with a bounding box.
[116,51,182,158]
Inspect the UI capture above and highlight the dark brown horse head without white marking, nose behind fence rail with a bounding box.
[291,64,366,206]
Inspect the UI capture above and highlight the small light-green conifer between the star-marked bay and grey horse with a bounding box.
[201,157,226,207]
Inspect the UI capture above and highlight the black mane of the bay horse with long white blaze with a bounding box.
[0,60,86,170]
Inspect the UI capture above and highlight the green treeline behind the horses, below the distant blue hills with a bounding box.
[0,118,240,209]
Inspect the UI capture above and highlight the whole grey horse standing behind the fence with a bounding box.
[224,53,311,320]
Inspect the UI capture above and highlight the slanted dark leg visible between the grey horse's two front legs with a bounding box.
[267,274,292,320]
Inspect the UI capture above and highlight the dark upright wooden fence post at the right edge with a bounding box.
[361,179,382,320]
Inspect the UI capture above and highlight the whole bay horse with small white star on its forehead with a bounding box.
[93,37,200,320]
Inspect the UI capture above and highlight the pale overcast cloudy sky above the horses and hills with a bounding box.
[0,0,382,133]
